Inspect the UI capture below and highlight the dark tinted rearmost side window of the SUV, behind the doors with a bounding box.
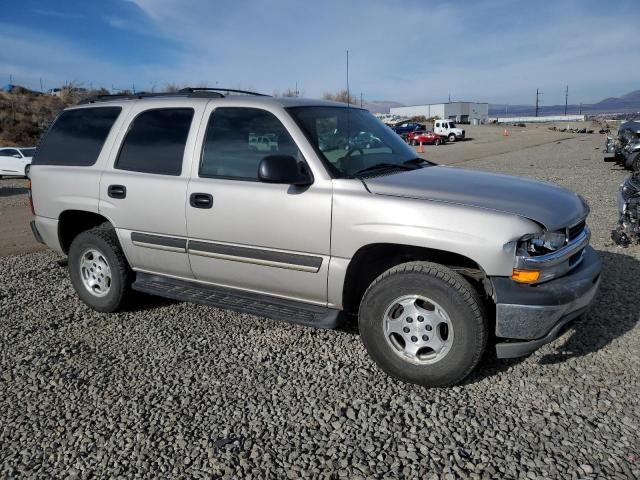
[32,107,122,167]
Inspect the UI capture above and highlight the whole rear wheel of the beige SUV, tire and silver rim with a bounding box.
[69,226,133,312]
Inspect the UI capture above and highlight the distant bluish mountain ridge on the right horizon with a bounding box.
[489,90,640,117]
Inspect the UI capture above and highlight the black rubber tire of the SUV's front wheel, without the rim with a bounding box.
[358,262,488,387]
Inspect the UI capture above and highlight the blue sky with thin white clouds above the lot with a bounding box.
[0,0,640,105]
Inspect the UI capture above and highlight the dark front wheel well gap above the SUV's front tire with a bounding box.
[342,243,491,313]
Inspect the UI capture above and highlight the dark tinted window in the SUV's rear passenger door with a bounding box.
[115,108,193,175]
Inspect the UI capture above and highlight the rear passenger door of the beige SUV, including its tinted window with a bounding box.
[99,99,205,278]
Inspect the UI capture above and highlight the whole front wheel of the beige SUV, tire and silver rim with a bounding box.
[358,262,488,387]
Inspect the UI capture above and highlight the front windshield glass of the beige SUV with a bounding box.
[288,107,426,177]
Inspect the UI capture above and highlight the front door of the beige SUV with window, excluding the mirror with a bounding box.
[187,106,331,304]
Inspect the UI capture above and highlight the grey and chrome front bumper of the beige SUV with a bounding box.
[491,247,602,358]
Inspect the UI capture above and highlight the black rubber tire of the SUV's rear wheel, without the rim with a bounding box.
[68,225,133,312]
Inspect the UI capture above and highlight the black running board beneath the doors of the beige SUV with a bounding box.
[132,272,340,329]
